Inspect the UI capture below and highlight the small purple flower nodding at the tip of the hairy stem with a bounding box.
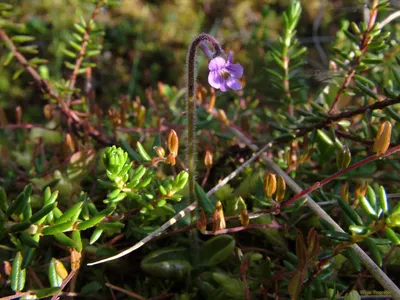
[208,51,243,92]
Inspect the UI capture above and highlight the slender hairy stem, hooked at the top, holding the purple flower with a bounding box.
[186,33,223,203]
